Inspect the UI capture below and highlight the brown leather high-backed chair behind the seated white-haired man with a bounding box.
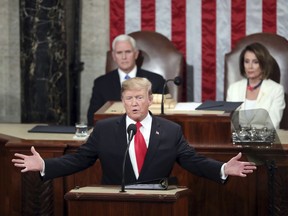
[106,31,184,101]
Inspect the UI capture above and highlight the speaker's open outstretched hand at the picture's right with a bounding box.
[224,152,256,177]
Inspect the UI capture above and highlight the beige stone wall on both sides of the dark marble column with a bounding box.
[0,0,109,122]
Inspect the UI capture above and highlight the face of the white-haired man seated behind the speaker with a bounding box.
[112,41,139,73]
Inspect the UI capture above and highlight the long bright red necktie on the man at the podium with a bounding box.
[134,122,147,173]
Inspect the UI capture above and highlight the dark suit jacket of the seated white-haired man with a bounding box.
[87,68,165,126]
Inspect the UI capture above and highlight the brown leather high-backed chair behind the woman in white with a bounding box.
[224,33,288,129]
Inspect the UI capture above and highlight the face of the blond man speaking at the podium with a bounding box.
[122,89,153,121]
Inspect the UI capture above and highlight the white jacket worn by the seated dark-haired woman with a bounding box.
[226,79,285,128]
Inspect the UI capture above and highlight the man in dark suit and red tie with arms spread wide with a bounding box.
[12,77,256,185]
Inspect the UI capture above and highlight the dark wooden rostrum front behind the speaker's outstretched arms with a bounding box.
[0,124,288,216]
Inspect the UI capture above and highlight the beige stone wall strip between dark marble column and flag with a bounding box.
[80,0,110,121]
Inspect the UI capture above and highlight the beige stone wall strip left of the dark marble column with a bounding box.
[0,0,21,122]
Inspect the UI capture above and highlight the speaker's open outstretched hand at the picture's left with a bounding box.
[12,146,44,172]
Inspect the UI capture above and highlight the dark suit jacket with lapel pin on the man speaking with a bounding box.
[44,115,223,185]
